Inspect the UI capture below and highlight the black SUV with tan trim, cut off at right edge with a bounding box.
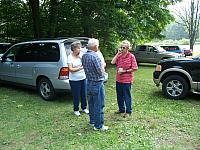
[153,55,200,99]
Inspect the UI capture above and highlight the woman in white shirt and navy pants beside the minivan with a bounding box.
[68,41,89,116]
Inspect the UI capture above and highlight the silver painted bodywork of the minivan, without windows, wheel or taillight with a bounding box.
[0,38,86,90]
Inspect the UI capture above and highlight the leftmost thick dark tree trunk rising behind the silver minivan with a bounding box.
[29,0,40,38]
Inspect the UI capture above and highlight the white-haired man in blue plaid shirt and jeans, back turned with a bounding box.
[82,38,108,130]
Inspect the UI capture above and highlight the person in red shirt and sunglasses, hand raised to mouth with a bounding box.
[111,40,138,116]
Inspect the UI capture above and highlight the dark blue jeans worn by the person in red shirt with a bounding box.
[116,82,132,113]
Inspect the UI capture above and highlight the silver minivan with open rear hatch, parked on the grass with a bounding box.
[0,37,89,100]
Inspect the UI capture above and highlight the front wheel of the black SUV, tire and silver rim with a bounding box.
[162,75,189,100]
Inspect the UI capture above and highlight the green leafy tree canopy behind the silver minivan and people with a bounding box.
[0,0,181,55]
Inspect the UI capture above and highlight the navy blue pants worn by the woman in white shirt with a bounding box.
[69,79,87,111]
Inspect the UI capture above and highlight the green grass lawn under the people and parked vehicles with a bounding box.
[0,65,200,150]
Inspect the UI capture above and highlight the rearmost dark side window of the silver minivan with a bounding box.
[34,43,60,62]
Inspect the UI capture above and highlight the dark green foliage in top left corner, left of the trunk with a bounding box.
[0,0,32,41]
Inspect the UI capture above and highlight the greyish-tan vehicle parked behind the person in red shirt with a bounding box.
[133,45,182,64]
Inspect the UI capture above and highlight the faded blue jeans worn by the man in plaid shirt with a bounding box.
[87,81,105,129]
